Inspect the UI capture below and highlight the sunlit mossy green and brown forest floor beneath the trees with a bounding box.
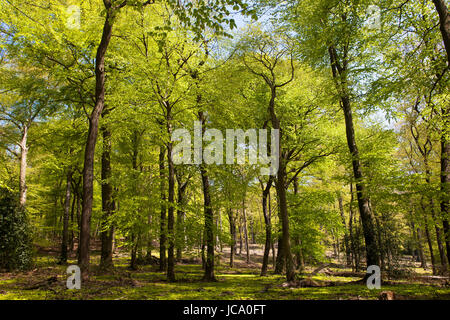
[0,245,450,300]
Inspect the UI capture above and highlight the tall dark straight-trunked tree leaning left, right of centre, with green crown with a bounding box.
[286,0,380,277]
